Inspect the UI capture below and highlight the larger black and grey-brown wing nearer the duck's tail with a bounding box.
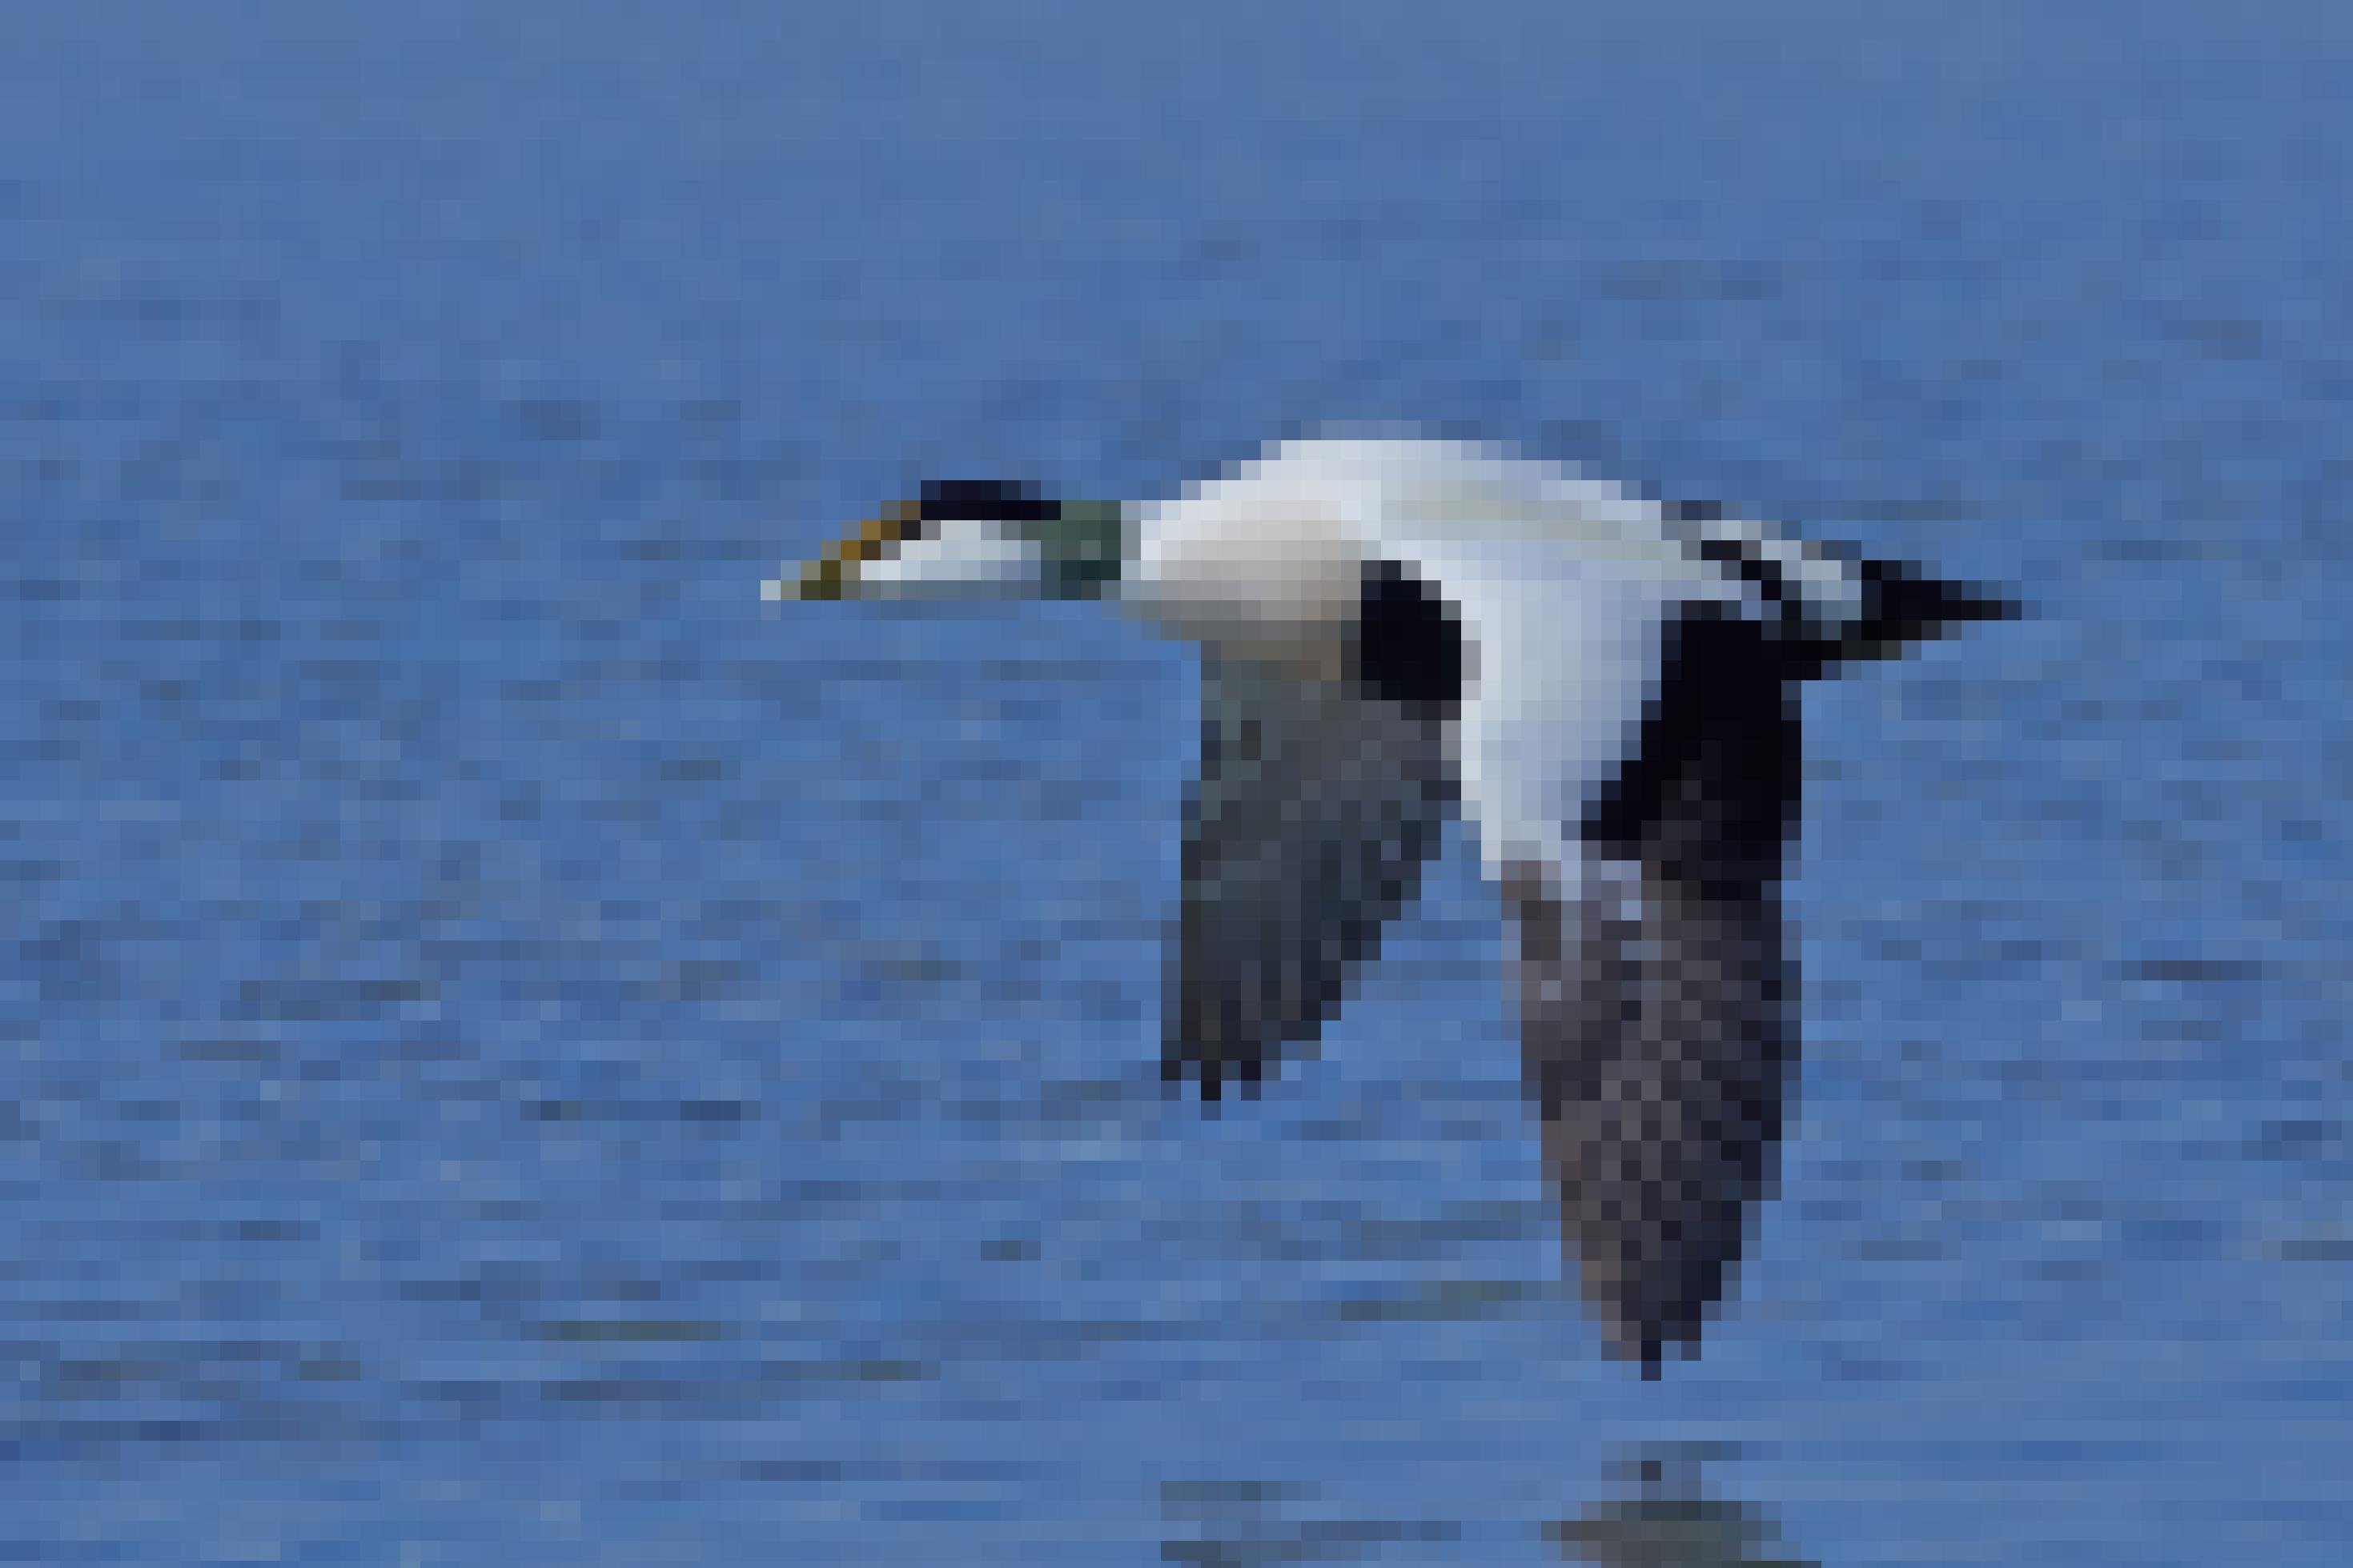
[1506,618,1800,1375]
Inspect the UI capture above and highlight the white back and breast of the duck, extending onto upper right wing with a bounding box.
[1127,439,1769,898]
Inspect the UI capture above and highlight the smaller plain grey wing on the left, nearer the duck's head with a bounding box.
[1160,656,1454,1101]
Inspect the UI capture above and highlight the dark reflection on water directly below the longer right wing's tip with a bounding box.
[1544,1443,1814,1568]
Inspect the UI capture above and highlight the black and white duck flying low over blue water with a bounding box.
[762,439,2017,1378]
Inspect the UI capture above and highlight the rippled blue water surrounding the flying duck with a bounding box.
[0,0,2353,1566]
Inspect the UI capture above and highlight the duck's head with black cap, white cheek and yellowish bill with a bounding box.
[760,479,1130,600]
